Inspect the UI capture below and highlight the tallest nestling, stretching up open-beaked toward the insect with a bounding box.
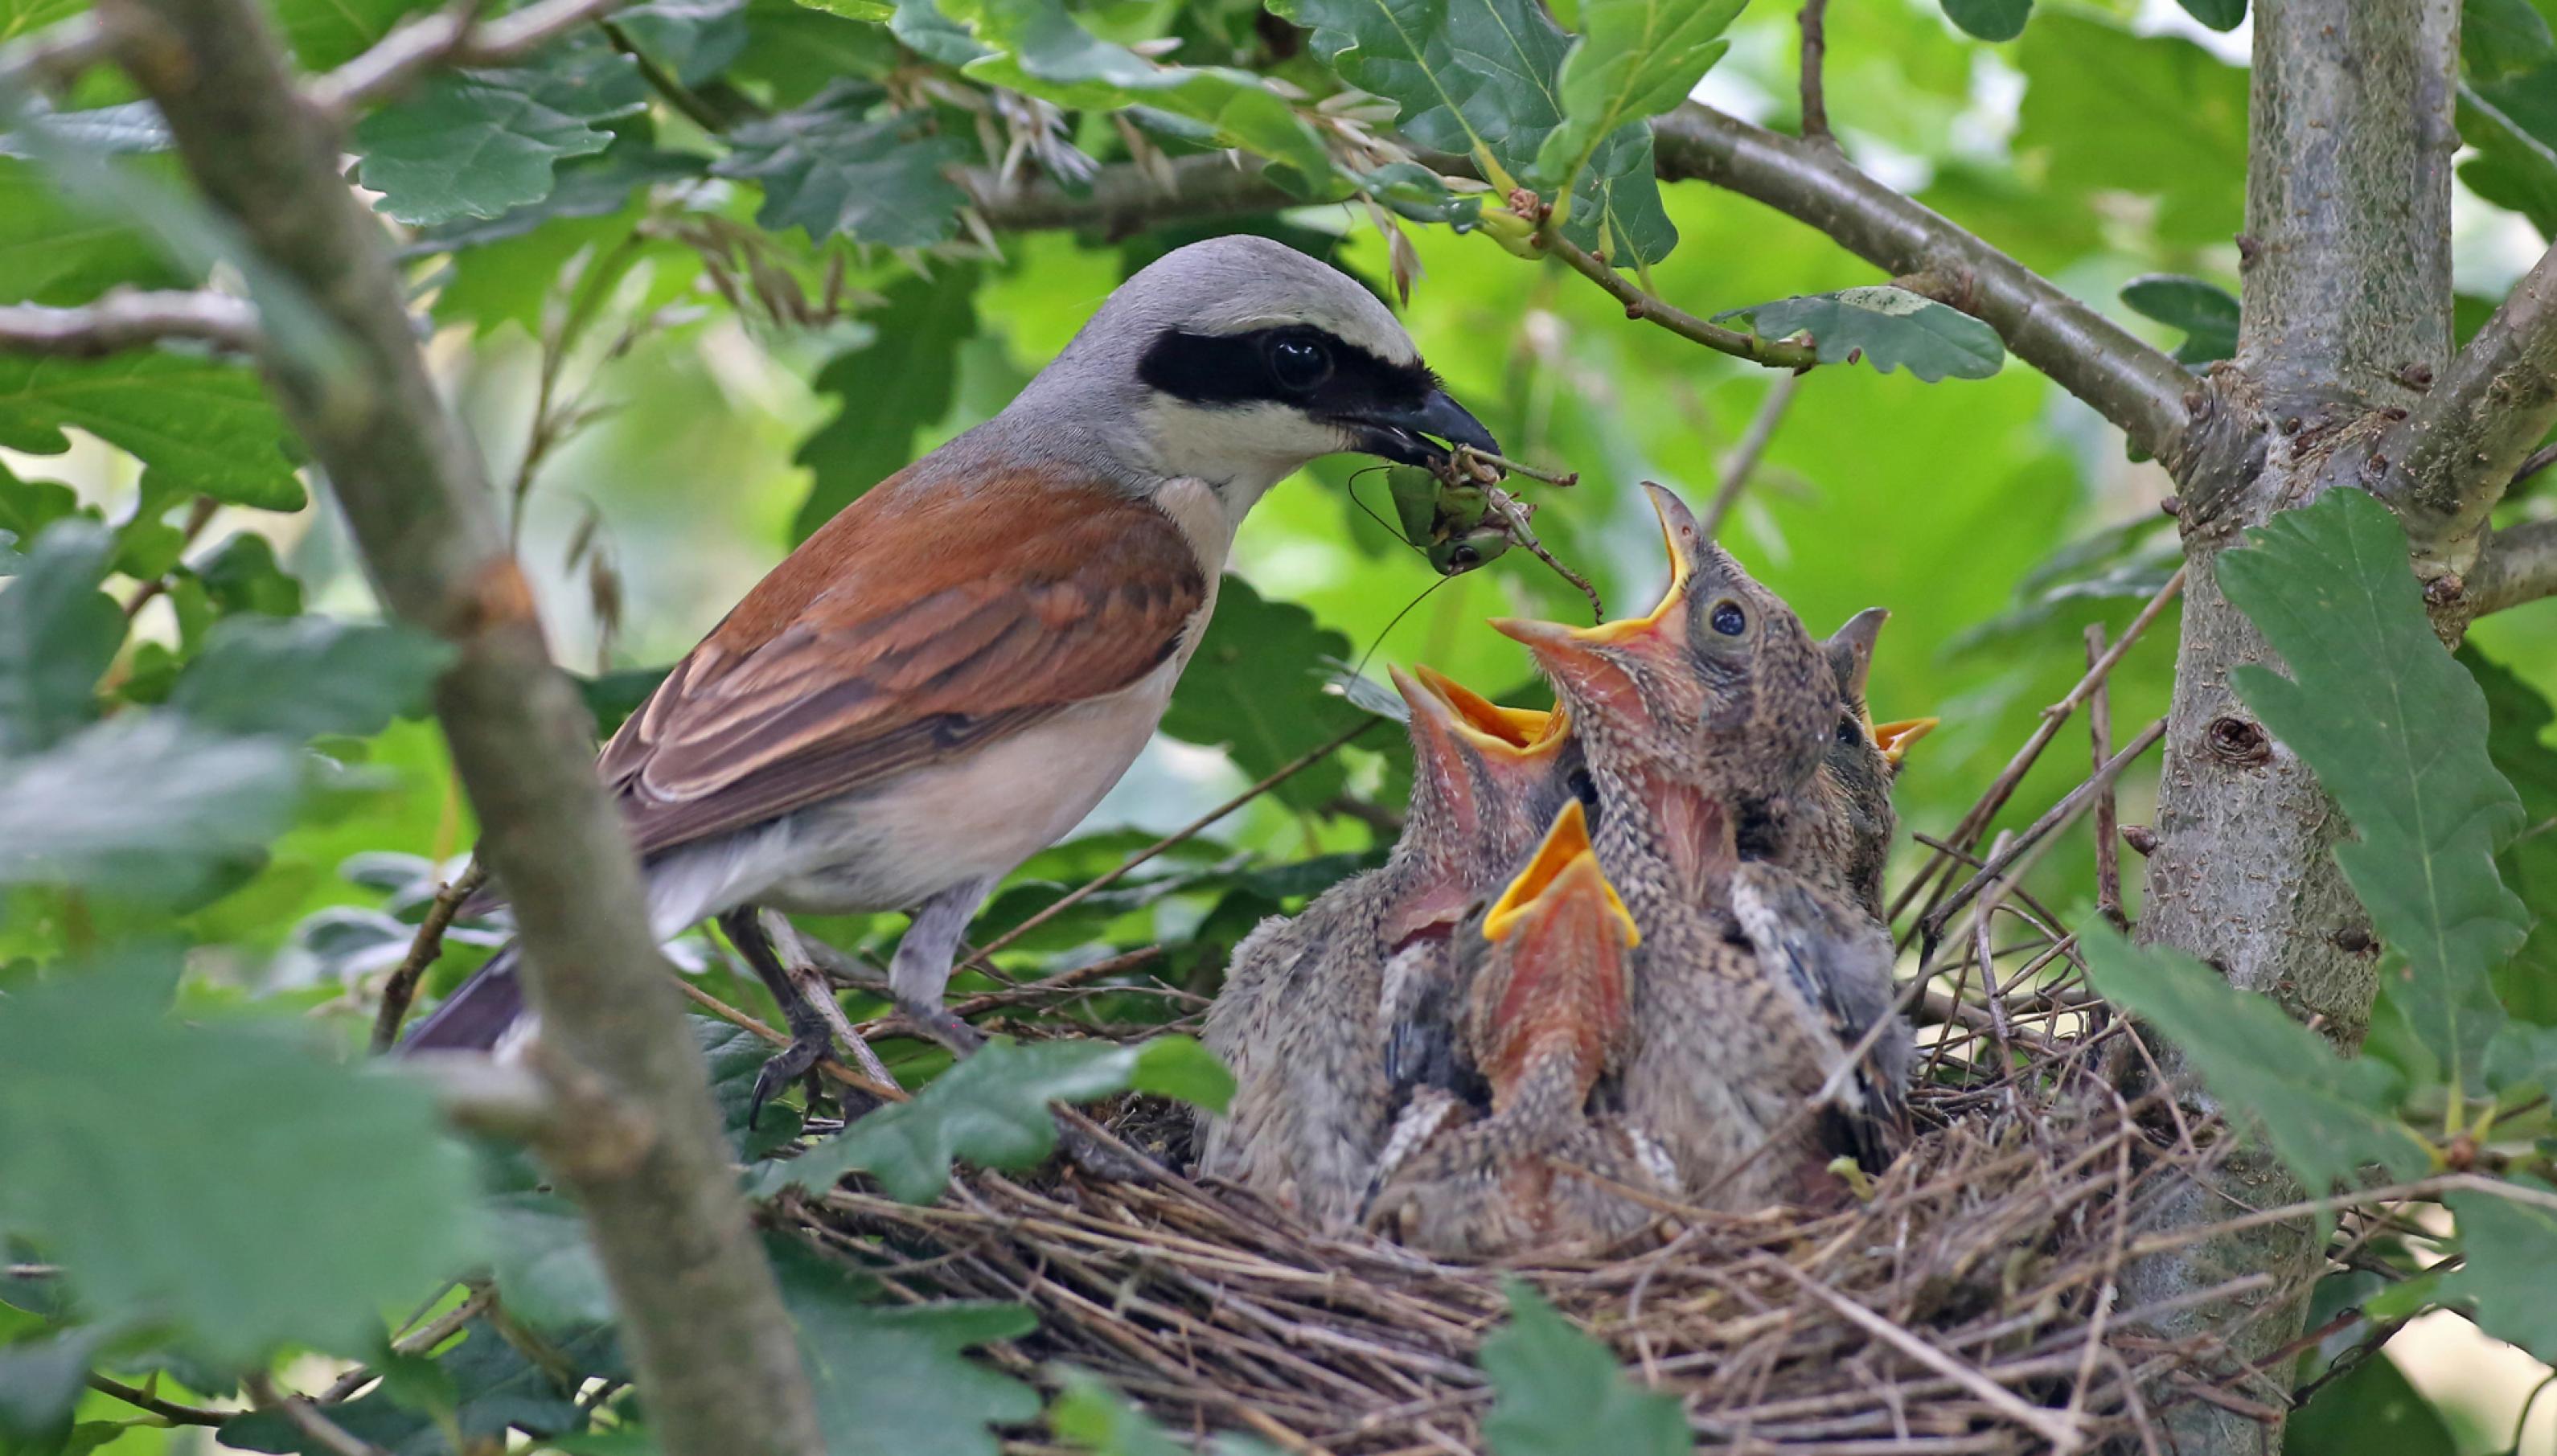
[1496,486,1900,1208]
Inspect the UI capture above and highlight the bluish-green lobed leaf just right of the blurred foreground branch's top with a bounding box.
[355,48,647,225]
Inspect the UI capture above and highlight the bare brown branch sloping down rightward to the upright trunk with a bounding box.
[1652,102,2197,471]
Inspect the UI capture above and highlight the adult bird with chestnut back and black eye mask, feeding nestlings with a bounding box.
[407,236,1498,1103]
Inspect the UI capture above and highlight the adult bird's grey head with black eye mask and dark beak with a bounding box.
[1008,236,1498,517]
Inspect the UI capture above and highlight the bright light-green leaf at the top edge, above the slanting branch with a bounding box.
[1537,0,1749,187]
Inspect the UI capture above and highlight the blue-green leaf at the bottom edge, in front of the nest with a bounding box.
[1483,1279,1695,1456]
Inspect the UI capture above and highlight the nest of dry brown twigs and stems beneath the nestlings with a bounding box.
[790,941,2301,1456]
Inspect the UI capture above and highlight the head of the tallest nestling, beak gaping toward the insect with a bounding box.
[1493,484,1838,852]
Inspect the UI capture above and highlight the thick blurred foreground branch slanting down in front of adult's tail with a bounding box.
[100,0,821,1456]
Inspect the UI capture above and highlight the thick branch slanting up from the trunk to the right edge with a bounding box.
[2370,248,2557,540]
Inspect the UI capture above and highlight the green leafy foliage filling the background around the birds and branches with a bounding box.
[0,0,2557,1454]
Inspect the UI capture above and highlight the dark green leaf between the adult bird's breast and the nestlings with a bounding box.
[1164,576,1365,809]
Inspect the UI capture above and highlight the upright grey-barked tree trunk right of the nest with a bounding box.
[2122,0,2460,1456]
